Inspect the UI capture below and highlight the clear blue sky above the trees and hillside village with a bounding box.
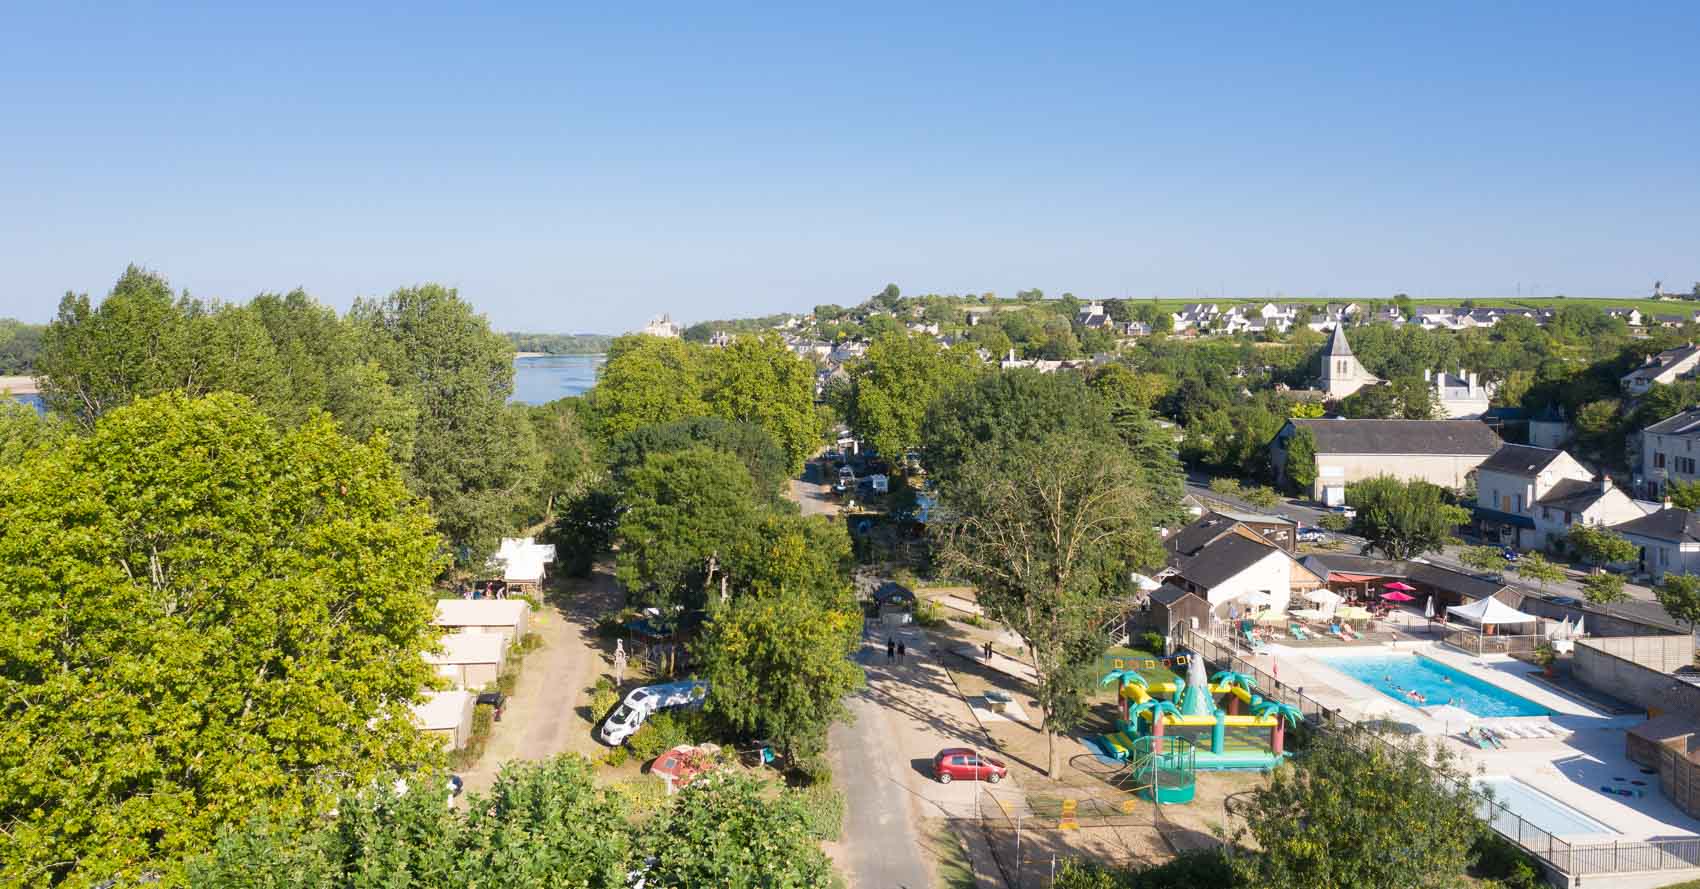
[0,0,1700,331]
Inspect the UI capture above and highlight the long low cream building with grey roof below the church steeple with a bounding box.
[1270,418,1503,507]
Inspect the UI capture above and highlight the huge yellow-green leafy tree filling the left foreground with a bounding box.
[0,394,440,886]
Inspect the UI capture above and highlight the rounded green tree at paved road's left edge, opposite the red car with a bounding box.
[692,590,862,765]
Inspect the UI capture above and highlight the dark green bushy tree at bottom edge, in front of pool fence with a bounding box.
[1233,733,1482,889]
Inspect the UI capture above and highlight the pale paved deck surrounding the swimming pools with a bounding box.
[1255,641,1700,843]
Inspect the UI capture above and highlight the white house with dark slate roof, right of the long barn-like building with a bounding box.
[1476,445,1646,549]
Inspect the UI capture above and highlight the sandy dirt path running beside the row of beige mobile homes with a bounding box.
[461,563,624,790]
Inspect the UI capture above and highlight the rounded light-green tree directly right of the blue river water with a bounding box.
[590,333,709,442]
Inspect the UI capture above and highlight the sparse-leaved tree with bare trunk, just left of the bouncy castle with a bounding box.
[940,433,1161,775]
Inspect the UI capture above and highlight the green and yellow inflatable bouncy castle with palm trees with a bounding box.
[1100,654,1299,772]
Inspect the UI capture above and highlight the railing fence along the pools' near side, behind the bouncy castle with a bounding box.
[1182,629,1700,889]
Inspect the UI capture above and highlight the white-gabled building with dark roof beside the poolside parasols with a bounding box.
[1168,525,1323,619]
